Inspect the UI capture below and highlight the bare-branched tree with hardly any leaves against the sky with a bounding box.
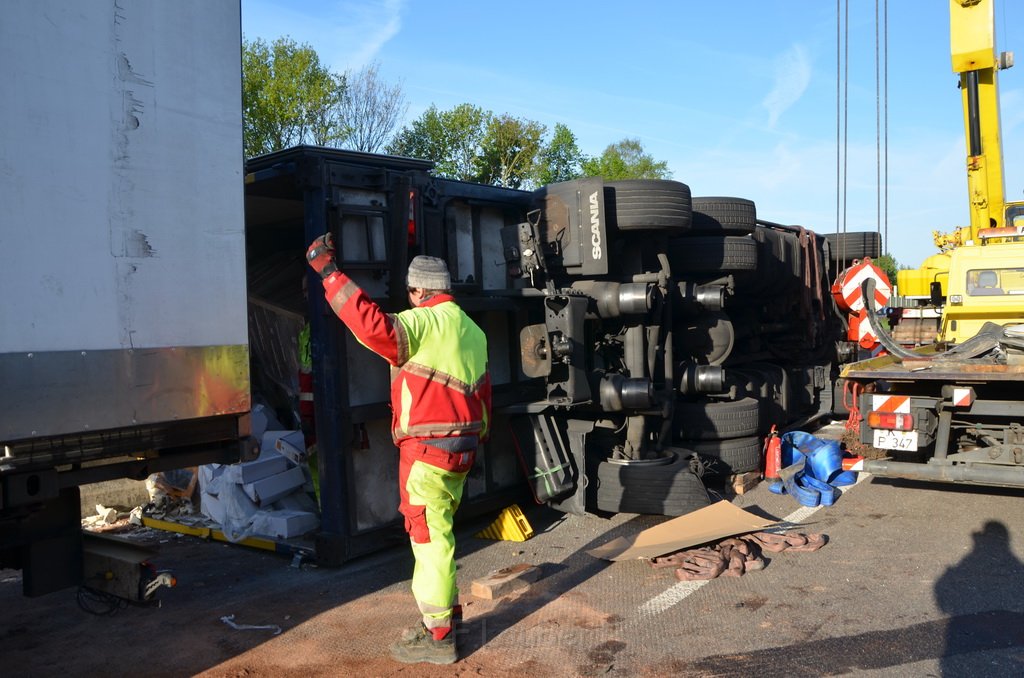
[341,62,409,153]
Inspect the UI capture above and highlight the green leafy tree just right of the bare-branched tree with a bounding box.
[387,103,490,181]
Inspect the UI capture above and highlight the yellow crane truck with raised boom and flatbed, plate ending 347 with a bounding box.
[841,0,1024,488]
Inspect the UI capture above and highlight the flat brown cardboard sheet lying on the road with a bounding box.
[587,501,775,560]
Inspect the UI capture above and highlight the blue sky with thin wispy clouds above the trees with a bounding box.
[242,0,1024,266]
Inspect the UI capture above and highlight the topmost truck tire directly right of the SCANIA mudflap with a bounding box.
[604,179,692,231]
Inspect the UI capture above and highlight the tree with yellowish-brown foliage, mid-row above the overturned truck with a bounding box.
[476,114,546,188]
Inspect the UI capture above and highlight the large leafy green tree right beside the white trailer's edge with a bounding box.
[242,37,348,158]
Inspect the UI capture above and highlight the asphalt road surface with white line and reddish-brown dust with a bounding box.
[0,450,1024,677]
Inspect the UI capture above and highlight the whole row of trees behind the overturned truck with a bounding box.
[242,37,672,189]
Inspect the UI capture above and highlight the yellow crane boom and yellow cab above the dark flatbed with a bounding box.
[896,0,1024,344]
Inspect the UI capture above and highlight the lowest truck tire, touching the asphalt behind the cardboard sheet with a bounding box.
[588,455,711,516]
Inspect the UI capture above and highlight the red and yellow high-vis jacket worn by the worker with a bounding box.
[324,272,490,442]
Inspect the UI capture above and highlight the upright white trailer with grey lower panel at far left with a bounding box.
[0,0,250,595]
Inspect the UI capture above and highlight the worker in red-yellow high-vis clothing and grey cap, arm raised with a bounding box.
[306,236,490,664]
